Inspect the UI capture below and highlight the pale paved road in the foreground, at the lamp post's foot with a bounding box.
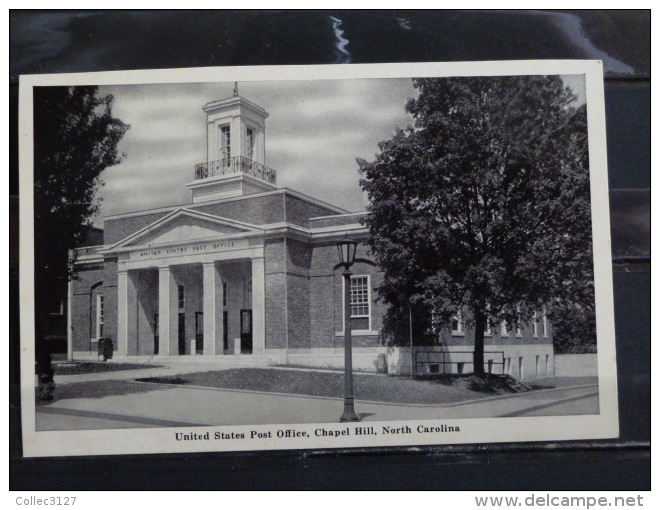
[36,369,598,430]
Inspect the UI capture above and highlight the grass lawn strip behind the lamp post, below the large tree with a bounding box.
[131,368,549,404]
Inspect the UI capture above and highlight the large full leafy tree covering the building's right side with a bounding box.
[358,76,593,375]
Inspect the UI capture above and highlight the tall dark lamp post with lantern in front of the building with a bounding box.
[335,239,360,421]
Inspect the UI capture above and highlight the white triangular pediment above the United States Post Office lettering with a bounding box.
[111,205,262,249]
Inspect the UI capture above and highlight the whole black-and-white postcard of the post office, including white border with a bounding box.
[19,60,618,456]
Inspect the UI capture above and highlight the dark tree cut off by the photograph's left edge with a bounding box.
[34,87,129,380]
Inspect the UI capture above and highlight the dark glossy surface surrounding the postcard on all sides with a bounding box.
[9,11,651,490]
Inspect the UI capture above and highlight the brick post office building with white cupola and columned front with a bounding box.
[69,94,551,370]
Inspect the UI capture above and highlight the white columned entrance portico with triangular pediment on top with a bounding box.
[105,209,265,356]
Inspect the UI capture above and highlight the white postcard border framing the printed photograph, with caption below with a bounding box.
[19,60,619,457]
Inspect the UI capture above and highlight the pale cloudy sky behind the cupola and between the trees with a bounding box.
[95,75,585,226]
